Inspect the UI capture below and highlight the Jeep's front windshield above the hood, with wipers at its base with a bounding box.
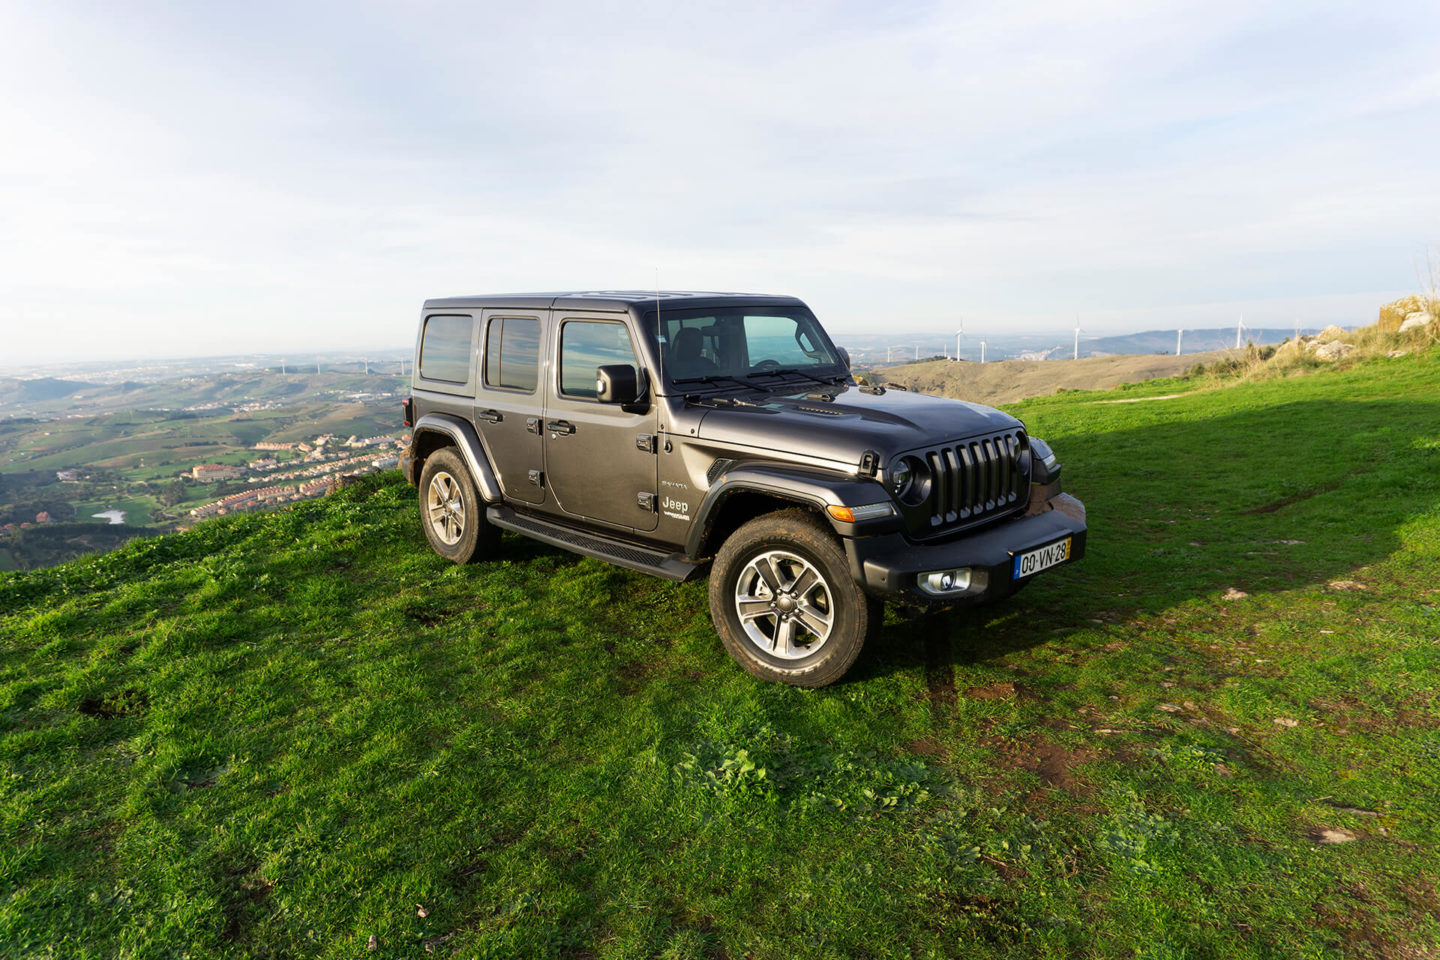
[658,307,845,393]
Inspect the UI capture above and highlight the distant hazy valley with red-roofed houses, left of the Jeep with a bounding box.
[0,364,409,570]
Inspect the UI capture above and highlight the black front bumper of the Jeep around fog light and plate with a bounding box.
[845,492,1086,603]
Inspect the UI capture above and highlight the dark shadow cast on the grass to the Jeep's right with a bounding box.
[845,400,1440,685]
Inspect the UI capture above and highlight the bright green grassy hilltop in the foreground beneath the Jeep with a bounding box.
[8,350,1440,959]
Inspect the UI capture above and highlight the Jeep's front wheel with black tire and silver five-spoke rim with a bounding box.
[710,510,884,687]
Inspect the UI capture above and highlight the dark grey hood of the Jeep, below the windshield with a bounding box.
[697,384,1020,463]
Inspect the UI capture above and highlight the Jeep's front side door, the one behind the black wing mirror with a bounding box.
[544,312,660,533]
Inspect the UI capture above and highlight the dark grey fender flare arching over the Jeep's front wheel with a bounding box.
[685,463,900,557]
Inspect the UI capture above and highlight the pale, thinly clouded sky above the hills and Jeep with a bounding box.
[0,0,1440,366]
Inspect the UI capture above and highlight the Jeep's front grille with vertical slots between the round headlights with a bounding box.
[923,430,1030,531]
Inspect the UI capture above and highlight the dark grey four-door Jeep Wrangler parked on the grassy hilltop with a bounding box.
[400,291,1086,687]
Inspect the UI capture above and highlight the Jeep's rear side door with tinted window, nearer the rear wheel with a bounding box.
[475,309,549,504]
